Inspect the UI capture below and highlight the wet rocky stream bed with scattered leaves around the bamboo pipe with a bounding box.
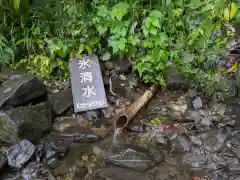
[0,60,240,180]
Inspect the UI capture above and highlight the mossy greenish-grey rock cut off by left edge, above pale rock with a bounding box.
[0,112,19,144]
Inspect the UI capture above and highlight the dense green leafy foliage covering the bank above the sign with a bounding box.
[0,0,240,88]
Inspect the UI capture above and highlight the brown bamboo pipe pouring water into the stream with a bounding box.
[113,85,158,133]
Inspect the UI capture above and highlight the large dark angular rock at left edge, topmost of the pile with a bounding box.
[0,73,46,109]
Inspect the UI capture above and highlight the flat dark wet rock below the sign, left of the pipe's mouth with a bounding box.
[58,126,101,143]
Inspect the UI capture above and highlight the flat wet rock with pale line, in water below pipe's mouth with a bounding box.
[104,145,155,171]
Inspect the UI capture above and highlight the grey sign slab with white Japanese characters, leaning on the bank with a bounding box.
[70,56,107,112]
